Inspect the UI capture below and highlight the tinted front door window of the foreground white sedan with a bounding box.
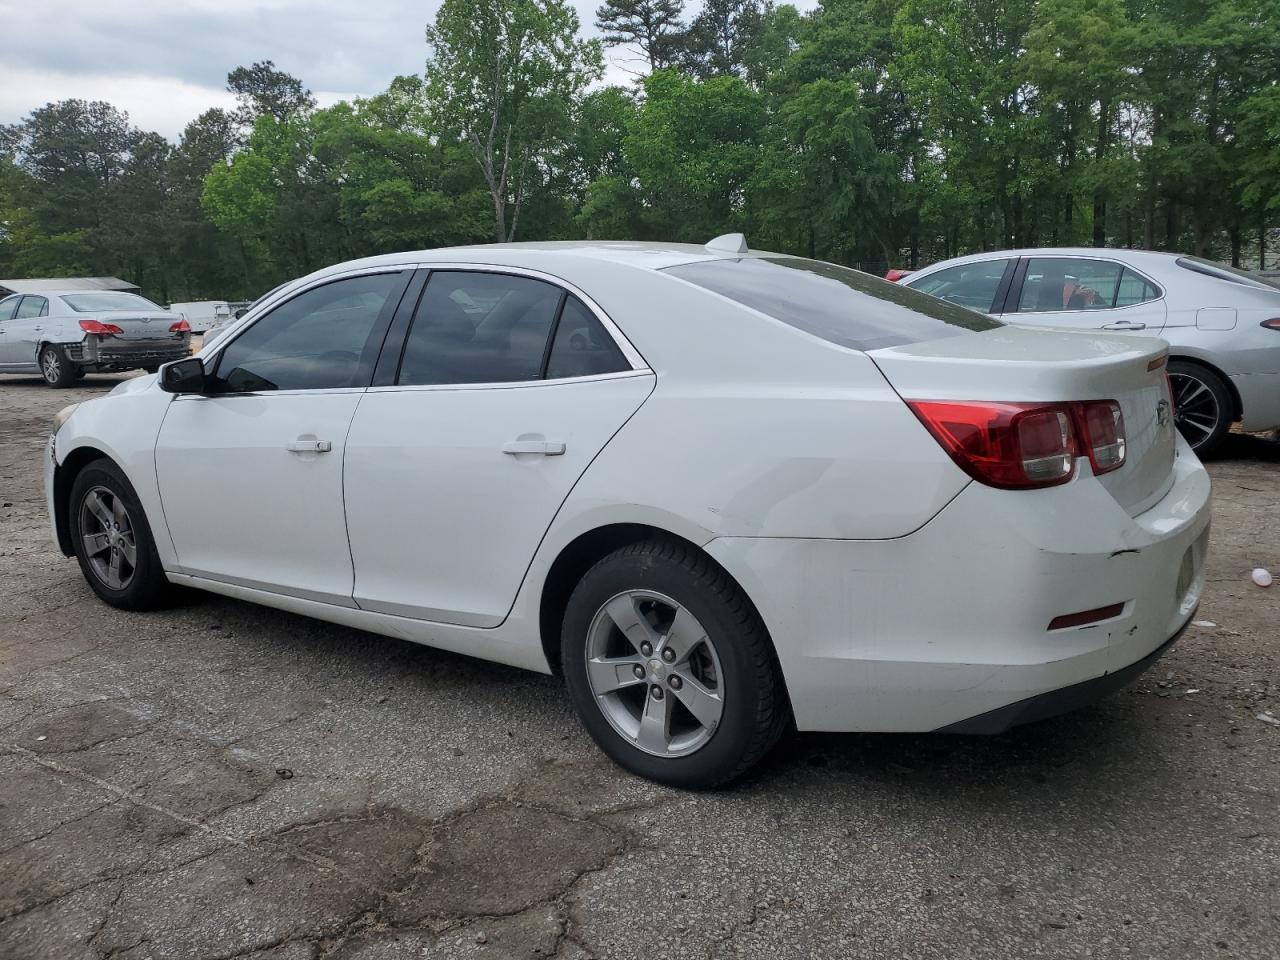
[216,273,403,393]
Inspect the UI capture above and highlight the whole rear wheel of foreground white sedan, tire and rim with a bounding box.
[561,540,790,788]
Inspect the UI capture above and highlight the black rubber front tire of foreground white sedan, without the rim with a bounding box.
[67,457,177,611]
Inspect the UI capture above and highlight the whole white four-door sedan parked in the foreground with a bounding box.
[46,236,1210,786]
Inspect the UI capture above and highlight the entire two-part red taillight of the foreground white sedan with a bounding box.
[908,401,1125,490]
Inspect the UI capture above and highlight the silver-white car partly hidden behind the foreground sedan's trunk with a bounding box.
[901,247,1280,456]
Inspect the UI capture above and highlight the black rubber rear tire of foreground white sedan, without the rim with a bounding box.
[561,539,791,790]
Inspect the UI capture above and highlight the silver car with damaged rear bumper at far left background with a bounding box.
[0,289,191,387]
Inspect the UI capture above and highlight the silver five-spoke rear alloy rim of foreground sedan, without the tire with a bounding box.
[586,590,724,756]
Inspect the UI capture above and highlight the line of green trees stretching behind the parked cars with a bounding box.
[0,0,1280,301]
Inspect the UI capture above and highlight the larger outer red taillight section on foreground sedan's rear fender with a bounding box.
[908,401,1075,490]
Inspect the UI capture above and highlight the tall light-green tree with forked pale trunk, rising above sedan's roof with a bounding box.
[426,0,603,242]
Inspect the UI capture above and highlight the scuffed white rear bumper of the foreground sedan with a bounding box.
[707,440,1211,732]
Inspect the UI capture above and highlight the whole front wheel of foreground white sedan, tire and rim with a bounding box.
[68,458,172,611]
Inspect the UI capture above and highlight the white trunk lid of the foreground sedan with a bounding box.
[869,326,1178,516]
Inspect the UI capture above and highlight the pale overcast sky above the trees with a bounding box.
[0,0,817,140]
